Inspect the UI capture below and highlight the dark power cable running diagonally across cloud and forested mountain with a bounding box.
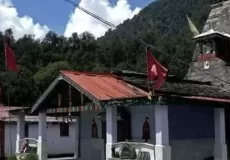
[65,0,230,85]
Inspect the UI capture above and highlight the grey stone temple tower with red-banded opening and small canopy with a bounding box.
[186,0,230,91]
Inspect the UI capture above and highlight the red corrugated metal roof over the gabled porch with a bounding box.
[61,71,148,100]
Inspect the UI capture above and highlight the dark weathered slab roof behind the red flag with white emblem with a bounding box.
[115,70,230,99]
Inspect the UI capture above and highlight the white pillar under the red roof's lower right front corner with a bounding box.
[106,107,117,160]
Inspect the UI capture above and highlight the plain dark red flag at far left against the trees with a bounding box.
[4,43,18,72]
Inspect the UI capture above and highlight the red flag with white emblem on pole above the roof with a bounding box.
[146,49,168,90]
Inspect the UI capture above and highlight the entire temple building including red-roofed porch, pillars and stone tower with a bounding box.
[11,1,230,160]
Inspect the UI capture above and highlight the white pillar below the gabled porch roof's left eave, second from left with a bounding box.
[37,112,47,160]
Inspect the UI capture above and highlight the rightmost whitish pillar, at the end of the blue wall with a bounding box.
[214,108,227,160]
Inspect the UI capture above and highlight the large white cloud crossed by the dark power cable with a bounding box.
[64,0,141,37]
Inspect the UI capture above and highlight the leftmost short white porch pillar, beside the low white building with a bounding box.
[16,114,25,153]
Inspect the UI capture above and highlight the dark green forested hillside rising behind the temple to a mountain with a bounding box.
[0,0,217,106]
